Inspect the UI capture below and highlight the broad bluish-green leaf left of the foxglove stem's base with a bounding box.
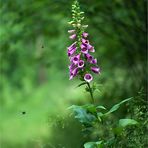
[69,105,96,125]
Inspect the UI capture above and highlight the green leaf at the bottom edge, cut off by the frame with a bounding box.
[84,141,103,148]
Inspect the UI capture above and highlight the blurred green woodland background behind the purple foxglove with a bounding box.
[0,0,147,148]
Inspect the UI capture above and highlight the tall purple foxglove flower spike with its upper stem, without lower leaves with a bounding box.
[67,0,100,102]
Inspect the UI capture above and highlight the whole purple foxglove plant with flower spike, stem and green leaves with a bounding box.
[67,0,138,148]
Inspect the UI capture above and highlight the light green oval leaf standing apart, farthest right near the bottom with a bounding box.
[119,119,138,127]
